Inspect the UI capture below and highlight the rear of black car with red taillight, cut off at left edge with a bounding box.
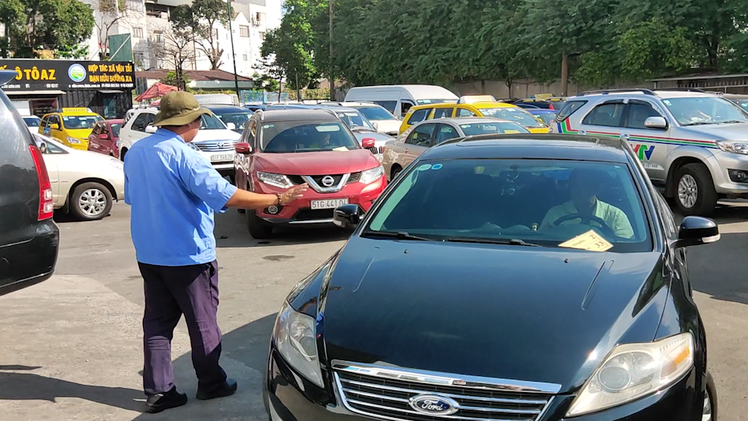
[0,71,60,295]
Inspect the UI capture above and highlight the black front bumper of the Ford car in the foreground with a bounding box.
[263,348,703,421]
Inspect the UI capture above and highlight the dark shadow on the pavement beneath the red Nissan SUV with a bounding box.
[214,209,351,247]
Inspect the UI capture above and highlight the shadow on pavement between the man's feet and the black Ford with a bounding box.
[133,314,276,421]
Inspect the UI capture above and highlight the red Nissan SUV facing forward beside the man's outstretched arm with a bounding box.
[235,109,387,239]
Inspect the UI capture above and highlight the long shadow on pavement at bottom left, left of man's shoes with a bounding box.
[0,365,143,411]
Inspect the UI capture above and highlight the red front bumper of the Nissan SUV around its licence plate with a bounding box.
[254,176,387,225]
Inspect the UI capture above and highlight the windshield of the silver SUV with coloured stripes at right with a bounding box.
[662,96,748,126]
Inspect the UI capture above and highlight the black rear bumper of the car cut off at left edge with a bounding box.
[0,219,60,295]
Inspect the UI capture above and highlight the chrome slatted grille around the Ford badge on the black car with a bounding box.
[333,362,560,421]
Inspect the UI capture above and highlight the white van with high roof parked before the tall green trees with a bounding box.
[345,85,458,118]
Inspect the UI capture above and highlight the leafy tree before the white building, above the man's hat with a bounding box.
[171,0,234,70]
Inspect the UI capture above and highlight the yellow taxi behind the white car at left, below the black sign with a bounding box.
[39,108,104,151]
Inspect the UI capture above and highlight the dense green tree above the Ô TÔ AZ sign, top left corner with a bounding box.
[0,0,94,57]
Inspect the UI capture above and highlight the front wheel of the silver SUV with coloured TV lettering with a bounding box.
[673,164,717,216]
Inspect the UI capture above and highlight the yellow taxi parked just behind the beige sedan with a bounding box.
[400,95,550,134]
